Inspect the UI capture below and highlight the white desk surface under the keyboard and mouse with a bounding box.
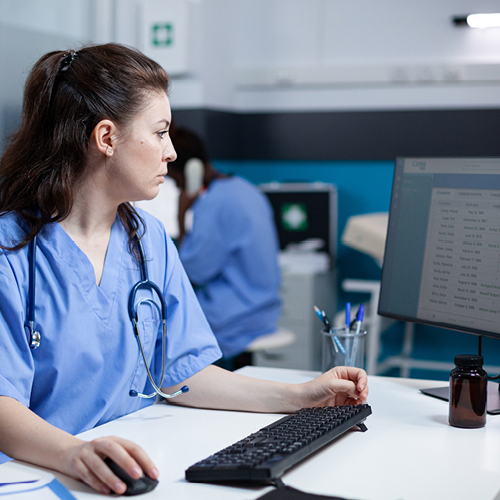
[0,367,500,500]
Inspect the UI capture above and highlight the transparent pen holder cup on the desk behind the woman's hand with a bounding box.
[321,328,366,372]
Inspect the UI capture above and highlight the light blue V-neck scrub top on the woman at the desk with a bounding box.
[0,211,221,448]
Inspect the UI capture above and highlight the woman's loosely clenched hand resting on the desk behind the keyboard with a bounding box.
[299,366,368,408]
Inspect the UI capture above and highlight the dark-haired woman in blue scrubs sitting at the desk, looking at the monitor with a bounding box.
[0,44,368,493]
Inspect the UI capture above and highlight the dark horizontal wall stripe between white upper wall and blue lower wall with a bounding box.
[173,109,500,161]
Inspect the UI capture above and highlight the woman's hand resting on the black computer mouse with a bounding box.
[61,436,158,495]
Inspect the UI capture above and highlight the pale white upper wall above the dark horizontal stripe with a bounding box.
[116,0,500,111]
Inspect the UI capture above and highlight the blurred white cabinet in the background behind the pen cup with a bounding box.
[253,271,337,370]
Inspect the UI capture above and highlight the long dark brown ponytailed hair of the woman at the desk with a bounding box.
[0,43,169,253]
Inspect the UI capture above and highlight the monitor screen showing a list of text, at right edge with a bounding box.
[378,158,500,338]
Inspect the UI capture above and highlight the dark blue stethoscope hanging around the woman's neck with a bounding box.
[25,236,189,398]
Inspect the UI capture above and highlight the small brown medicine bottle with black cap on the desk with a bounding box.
[449,354,488,429]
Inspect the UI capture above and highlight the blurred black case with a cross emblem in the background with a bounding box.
[259,182,337,264]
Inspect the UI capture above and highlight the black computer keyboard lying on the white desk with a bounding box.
[186,404,372,483]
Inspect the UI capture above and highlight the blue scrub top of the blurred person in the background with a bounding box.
[180,177,281,357]
